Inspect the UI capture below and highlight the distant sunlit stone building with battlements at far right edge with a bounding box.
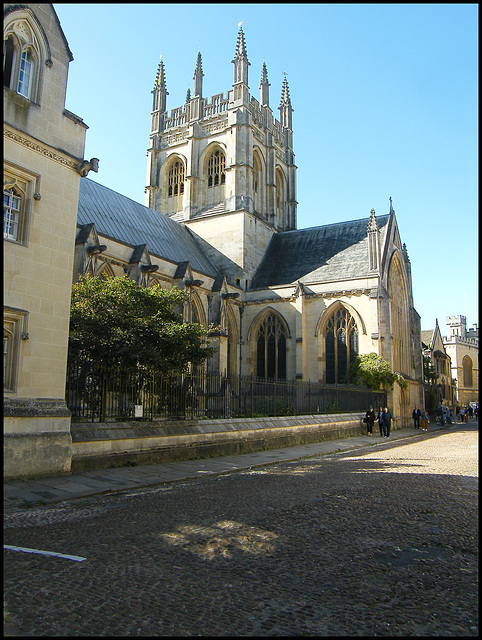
[443,316,479,406]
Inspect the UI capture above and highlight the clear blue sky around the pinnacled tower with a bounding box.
[54,3,478,335]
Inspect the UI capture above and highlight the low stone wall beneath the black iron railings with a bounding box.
[71,413,365,473]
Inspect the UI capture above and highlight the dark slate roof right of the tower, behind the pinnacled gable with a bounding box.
[250,215,389,289]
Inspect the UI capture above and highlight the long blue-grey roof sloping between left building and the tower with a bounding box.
[77,178,219,278]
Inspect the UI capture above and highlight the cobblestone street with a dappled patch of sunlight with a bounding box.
[4,423,479,636]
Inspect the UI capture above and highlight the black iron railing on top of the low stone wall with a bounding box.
[66,364,387,422]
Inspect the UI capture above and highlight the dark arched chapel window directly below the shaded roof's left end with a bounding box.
[256,313,286,380]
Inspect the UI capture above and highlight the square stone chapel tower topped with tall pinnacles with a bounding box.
[146,27,297,286]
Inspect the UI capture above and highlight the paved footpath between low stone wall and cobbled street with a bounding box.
[3,420,475,509]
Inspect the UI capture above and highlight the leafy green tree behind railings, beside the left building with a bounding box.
[68,276,215,372]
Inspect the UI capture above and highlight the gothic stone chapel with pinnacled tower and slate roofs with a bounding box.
[74,27,423,426]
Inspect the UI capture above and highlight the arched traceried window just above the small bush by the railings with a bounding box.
[324,307,358,384]
